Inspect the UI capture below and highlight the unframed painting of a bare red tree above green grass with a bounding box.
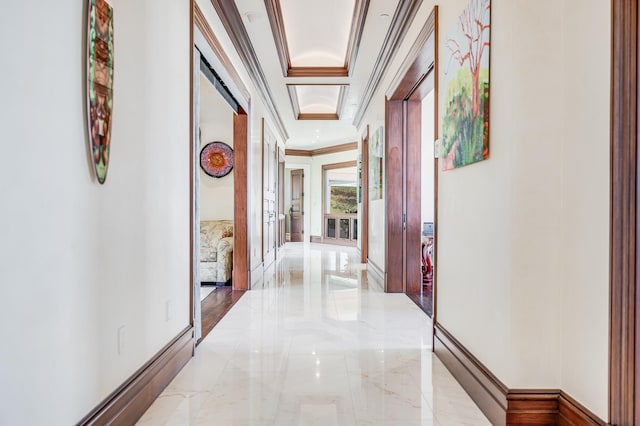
[440,0,491,170]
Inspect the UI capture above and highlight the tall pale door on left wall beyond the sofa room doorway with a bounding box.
[262,119,278,267]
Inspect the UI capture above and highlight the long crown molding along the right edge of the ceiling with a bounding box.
[353,0,422,128]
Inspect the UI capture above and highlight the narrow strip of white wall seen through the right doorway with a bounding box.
[420,91,435,223]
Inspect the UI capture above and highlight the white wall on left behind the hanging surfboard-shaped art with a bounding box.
[0,0,190,425]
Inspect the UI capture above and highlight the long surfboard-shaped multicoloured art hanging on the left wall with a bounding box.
[87,0,113,183]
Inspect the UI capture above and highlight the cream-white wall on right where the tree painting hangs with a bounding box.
[437,0,610,419]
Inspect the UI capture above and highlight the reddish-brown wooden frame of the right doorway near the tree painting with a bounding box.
[385,6,438,294]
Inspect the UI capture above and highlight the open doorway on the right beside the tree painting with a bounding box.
[385,6,438,316]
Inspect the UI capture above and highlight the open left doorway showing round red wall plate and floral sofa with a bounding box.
[190,22,250,343]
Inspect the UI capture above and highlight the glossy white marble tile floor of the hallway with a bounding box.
[138,243,490,426]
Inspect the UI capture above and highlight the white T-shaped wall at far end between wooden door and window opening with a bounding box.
[285,150,358,237]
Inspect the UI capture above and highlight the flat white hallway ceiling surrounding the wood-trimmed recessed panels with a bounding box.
[236,0,398,149]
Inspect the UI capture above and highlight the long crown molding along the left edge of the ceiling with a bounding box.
[211,0,289,141]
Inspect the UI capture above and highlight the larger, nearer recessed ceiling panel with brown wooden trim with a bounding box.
[265,0,369,77]
